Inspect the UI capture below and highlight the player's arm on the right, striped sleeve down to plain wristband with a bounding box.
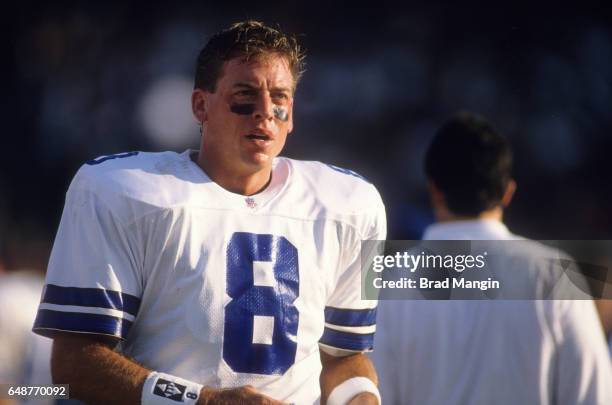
[319,190,386,405]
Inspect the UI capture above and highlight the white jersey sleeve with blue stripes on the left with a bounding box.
[33,175,142,339]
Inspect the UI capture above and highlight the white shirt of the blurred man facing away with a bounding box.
[372,220,612,405]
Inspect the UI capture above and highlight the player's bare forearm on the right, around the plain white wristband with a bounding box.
[319,352,378,405]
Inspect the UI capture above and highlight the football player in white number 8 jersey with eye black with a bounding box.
[34,21,386,405]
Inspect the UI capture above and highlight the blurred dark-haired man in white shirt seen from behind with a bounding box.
[373,113,612,405]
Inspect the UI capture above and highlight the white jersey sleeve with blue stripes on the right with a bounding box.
[319,197,386,356]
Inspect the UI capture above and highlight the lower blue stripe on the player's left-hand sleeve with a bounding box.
[32,309,132,339]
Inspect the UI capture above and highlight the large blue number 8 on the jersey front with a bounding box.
[223,232,300,375]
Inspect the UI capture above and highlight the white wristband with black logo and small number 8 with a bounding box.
[142,371,204,405]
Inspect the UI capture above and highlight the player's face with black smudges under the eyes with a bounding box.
[192,54,294,176]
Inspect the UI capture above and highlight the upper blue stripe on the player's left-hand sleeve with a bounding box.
[42,284,140,316]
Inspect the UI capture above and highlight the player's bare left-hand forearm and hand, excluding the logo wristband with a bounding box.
[51,333,281,405]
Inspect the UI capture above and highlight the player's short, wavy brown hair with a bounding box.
[195,21,305,93]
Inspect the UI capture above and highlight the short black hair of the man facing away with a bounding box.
[425,113,512,216]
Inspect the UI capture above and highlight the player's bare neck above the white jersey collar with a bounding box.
[196,150,272,195]
